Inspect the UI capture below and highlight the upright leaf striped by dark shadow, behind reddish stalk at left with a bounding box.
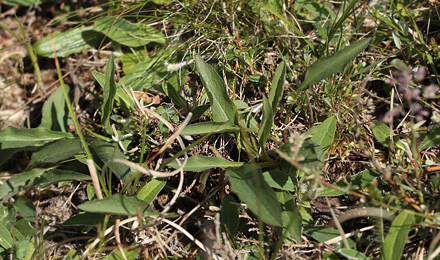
[39,88,72,132]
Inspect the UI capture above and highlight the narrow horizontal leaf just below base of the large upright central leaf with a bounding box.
[180,121,240,135]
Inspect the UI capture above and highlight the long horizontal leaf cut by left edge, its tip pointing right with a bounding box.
[0,126,74,149]
